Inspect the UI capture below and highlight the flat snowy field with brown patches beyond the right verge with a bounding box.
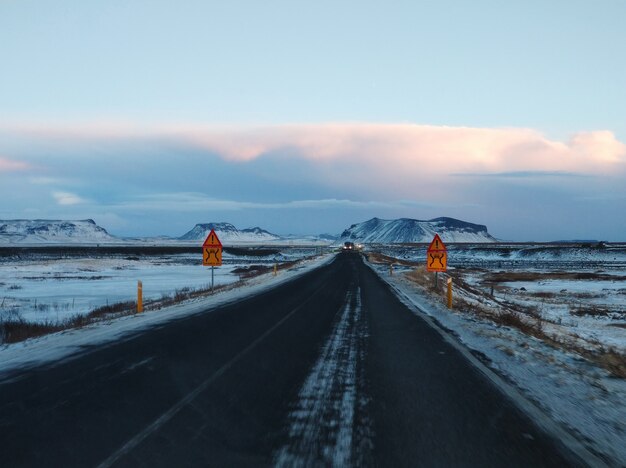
[370,244,626,353]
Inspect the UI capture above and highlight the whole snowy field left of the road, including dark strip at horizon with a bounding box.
[0,248,319,323]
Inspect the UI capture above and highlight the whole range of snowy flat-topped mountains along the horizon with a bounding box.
[0,218,496,245]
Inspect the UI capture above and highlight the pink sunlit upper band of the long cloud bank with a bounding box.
[0,123,626,179]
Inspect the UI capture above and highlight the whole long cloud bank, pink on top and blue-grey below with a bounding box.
[0,123,626,238]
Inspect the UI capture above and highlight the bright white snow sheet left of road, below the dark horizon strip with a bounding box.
[0,256,238,322]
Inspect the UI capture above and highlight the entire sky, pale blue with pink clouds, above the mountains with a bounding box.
[0,0,626,241]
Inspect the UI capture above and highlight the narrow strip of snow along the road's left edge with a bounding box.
[0,254,335,378]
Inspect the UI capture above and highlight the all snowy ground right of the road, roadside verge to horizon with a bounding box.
[372,245,626,466]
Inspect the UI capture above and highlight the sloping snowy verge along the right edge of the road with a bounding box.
[372,265,626,466]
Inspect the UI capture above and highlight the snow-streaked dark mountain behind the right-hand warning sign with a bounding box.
[340,218,496,244]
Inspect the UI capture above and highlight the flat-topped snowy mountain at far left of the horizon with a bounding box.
[0,219,119,244]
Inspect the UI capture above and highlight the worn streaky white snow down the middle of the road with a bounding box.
[275,288,368,467]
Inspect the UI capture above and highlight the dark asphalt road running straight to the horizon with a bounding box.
[0,253,572,467]
